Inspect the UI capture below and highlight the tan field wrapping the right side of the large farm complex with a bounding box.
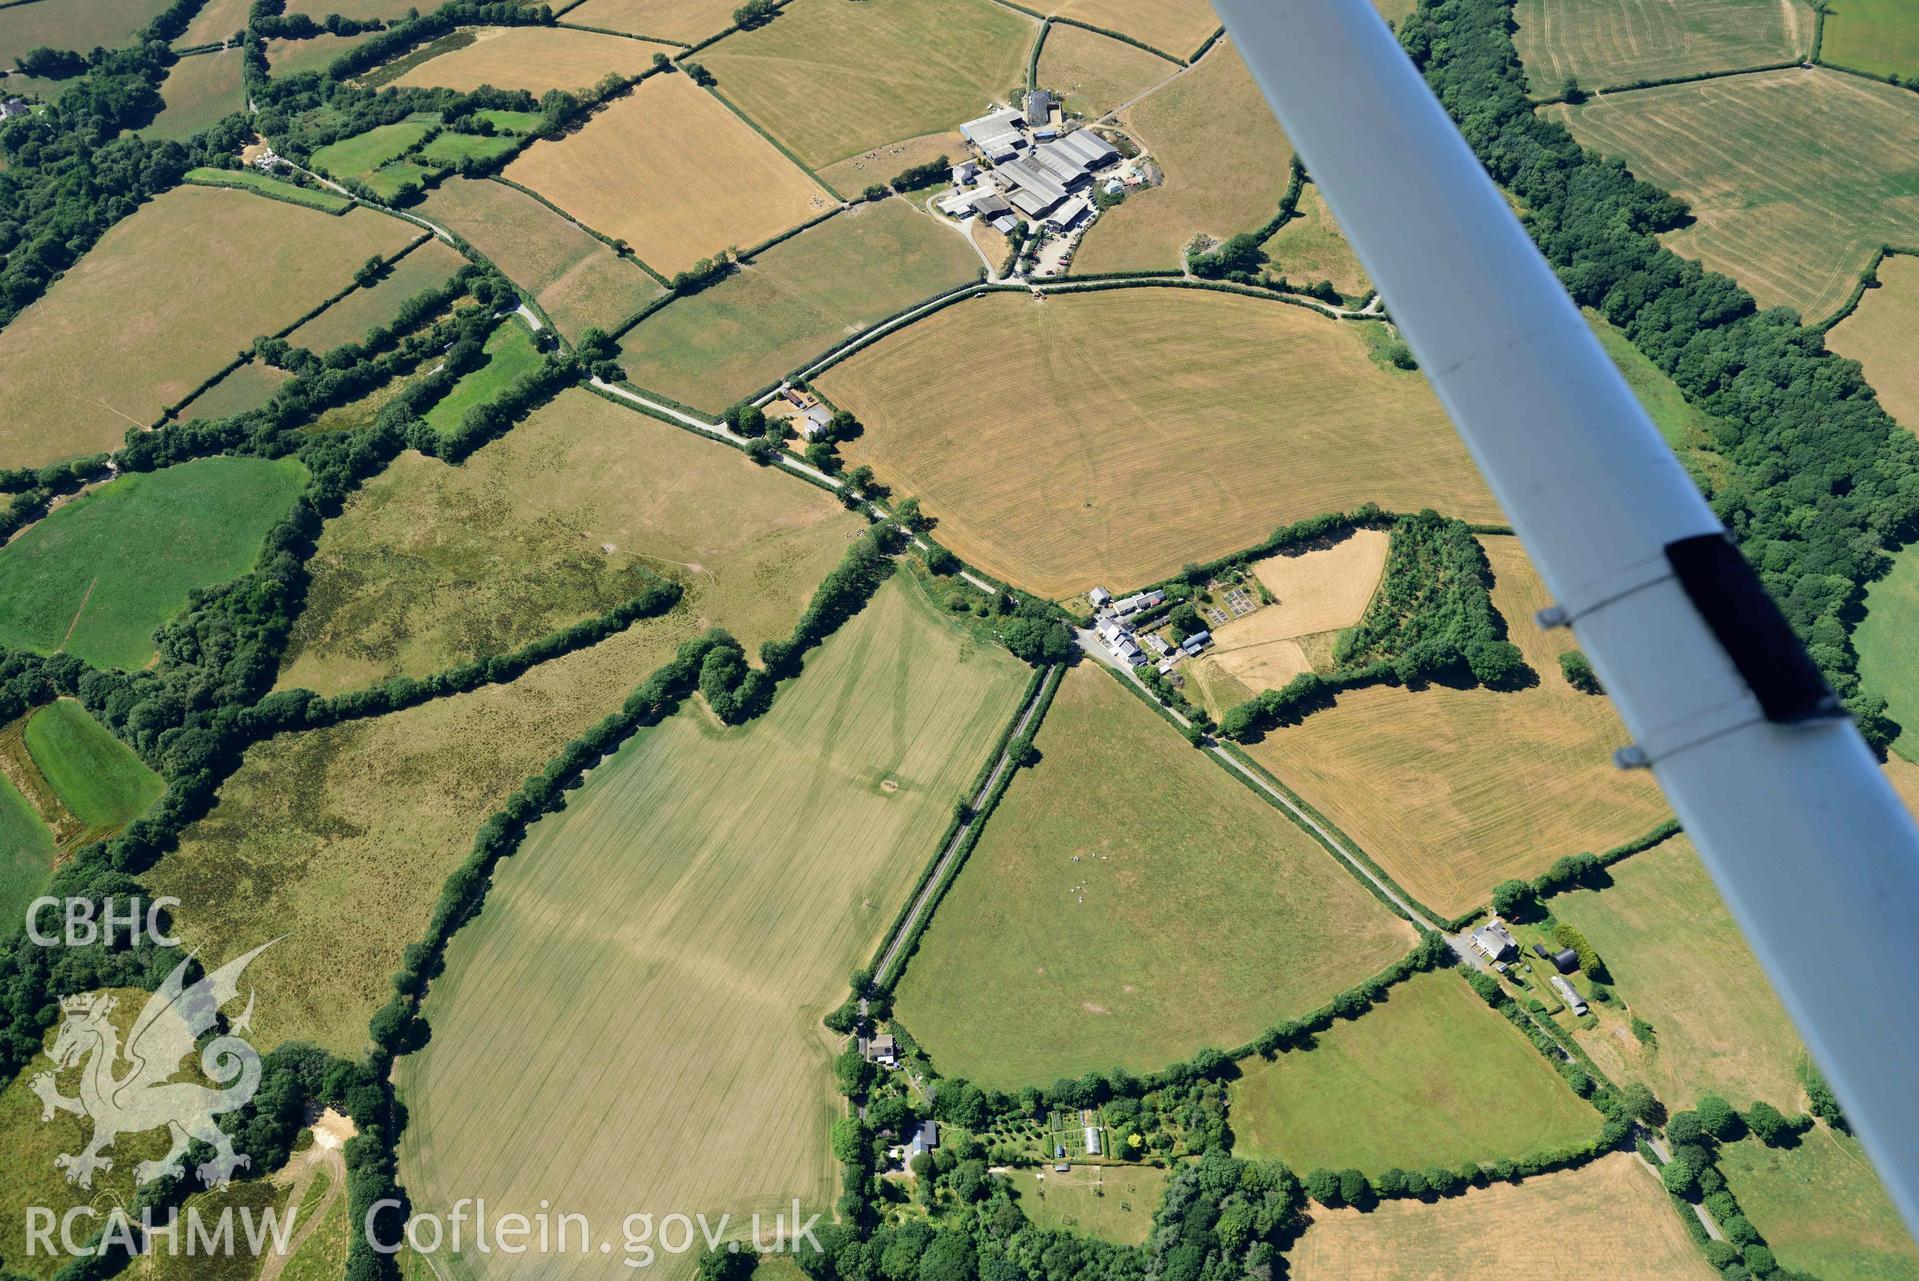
[1073,40,1293,272]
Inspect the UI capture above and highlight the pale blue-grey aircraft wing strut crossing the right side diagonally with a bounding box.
[1215,0,1919,1229]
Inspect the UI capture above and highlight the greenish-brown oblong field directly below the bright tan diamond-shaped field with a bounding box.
[620,198,981,412]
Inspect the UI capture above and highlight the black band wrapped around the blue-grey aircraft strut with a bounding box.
[1666,533,1846,725]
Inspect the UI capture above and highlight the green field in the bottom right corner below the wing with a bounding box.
[1719,1124,1919,1281]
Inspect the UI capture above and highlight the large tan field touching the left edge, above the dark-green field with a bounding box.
[0,185,418,466]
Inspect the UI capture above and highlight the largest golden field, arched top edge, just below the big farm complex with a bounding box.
[819,288,1499,598]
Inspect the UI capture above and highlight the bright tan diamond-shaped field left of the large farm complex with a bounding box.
[507,75,835,276]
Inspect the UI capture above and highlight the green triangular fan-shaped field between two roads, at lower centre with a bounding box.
[896,664,1414,1089]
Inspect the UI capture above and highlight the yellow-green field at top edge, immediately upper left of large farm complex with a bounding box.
[699,0,1038,169]
